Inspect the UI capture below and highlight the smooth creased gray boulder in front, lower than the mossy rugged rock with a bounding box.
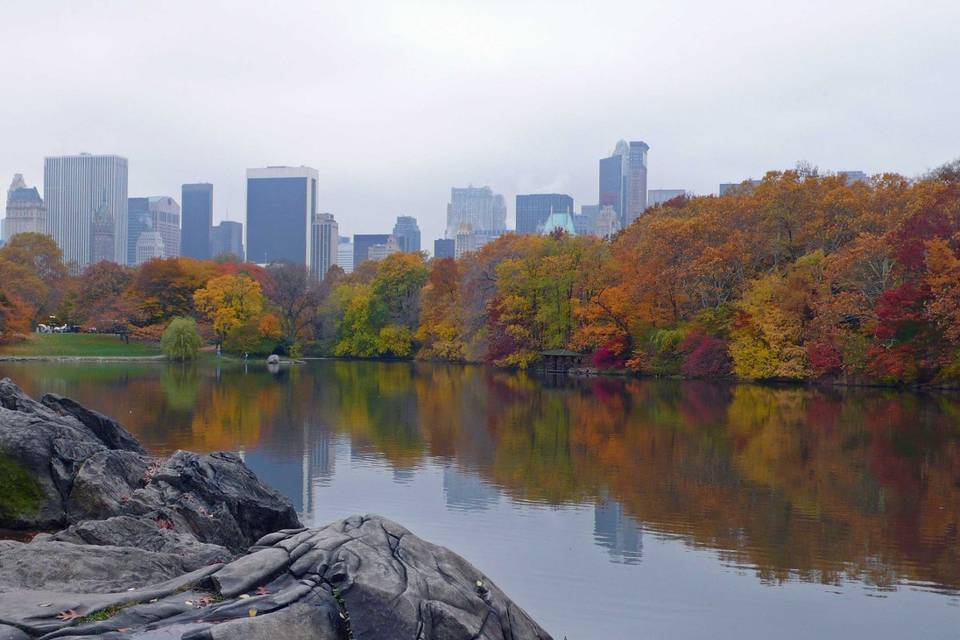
[0,516,550,640]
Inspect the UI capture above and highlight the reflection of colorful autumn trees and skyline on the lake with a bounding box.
[0,362,960,637]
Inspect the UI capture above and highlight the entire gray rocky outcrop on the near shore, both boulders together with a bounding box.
[0,379,550,640]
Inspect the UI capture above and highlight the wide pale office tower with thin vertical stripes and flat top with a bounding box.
[43,153,127,269]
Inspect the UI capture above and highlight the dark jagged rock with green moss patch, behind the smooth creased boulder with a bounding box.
[0,379,300,560]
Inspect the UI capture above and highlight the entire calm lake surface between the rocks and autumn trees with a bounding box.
[0,362,960,640]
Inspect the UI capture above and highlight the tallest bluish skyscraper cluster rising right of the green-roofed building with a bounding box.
[599,140,650,228]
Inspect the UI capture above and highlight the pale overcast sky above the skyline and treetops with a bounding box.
[0,0,960,249]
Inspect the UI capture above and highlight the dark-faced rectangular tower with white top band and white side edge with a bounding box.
[247,167,319,270]
